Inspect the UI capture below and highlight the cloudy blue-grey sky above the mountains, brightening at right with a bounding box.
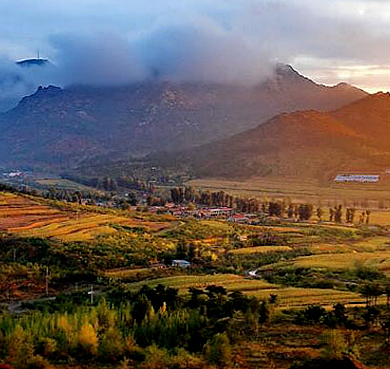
[0,0,390,107]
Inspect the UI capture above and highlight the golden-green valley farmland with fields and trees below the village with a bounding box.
[0,188,390,369]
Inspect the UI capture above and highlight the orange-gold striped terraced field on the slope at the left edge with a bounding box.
[0,193,169,241]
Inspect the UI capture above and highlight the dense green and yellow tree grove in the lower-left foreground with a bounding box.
[0,285,275,369]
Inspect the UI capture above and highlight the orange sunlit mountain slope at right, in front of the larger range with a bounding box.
[177,93,390,179]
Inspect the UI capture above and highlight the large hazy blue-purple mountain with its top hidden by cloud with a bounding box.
[0,65,367,168]
